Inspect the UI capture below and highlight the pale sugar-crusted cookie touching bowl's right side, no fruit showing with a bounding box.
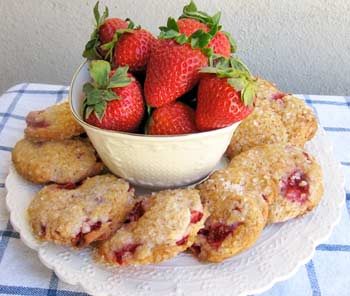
[226,108,288,159]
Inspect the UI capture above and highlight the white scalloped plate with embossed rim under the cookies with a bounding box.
[6,128,345,296]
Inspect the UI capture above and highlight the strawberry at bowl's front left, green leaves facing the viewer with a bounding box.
[83,60,145,132]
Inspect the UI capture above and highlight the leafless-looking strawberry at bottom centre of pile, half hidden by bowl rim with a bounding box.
[147,102,198,135]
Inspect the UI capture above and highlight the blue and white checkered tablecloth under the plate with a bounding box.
[0,83,350,296]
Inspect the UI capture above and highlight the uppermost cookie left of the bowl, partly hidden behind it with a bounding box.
[24,102,84,142]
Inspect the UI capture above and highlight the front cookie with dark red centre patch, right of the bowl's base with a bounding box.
[191,193,265,262]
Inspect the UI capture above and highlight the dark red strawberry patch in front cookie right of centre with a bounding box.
[199,222,242,249]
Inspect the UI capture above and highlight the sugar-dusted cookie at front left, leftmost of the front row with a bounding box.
[28,175,134,248]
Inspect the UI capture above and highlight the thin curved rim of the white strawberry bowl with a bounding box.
[68,59,242,140]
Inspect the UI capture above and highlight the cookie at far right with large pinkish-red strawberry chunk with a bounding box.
[229,144,323,223]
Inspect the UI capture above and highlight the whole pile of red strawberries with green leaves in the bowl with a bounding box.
[83,1,255,135]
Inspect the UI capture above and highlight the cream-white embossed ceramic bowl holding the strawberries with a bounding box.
[69,61,239,188]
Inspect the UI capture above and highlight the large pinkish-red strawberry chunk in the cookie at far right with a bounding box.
[281,171,309,203]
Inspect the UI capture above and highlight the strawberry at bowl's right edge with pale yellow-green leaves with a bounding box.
[196,58,255,131]
